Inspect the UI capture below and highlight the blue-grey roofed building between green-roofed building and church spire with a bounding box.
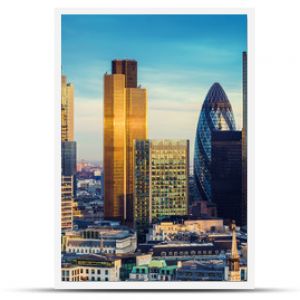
[176,260,226,281]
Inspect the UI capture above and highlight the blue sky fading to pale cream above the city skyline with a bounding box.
[62,15,247,161]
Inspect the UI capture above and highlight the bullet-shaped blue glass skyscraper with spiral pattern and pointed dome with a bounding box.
[194,82,235,202]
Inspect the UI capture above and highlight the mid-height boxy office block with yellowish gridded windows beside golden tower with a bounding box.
[134,140,189,228]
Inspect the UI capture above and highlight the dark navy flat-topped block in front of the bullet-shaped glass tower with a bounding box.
[211,131,242,226]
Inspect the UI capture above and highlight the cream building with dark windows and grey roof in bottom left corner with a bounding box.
[61,254,121,281]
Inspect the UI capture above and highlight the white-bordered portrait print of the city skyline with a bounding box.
[55,9,254,289]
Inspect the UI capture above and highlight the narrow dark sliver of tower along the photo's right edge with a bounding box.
[241,52,248,226]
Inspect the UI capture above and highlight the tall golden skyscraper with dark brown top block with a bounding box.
[104,60,148,224]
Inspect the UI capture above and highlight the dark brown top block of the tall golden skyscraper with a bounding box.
[111,59,137,88]
